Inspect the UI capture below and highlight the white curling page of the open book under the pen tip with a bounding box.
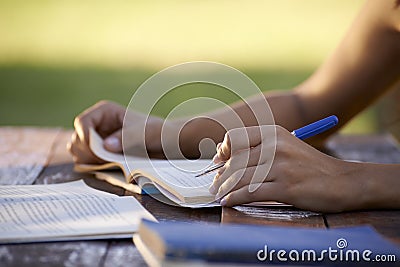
[87,129,220,206]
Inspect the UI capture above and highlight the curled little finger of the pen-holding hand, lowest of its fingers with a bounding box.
[220,182,285,207]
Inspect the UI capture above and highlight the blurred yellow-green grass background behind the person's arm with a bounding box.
[0,0,377,133]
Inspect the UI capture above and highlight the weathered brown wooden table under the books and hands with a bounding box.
[0,127,400,266]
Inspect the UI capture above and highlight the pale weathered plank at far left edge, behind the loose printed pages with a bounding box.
[0,127,60,184]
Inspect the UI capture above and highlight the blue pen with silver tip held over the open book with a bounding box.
[195,115,339,177]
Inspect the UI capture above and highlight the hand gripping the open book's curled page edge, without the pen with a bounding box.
[68,101,164,164]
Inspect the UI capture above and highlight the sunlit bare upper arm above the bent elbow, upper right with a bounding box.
[296,0,400,126]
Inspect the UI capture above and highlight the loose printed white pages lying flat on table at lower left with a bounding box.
[0,180,155,243]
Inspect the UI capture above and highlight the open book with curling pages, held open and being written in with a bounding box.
[75,129,219,208]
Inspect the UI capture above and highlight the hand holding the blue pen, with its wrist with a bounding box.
[210,126,365,212]
